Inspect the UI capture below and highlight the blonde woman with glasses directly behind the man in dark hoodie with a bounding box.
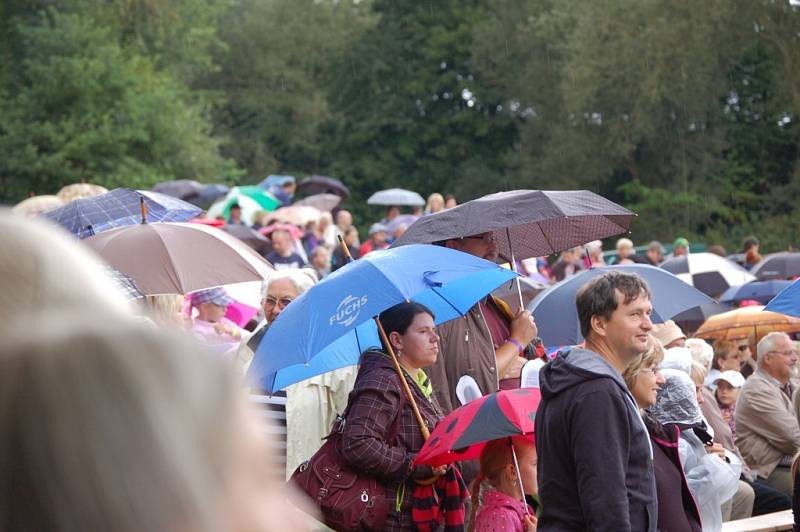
[622,336,702,532]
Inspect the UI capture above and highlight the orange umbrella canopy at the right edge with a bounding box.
[695,305,800,343]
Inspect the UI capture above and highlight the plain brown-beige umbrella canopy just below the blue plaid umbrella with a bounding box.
[83,223,275,296]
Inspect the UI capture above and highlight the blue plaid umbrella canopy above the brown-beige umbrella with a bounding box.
[42,188,203,238]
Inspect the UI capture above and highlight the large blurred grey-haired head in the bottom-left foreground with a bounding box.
[0,316,303,532]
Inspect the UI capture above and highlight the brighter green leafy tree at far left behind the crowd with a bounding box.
[0,9,234,204]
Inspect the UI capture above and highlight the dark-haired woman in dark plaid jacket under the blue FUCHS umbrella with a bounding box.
[341,303,445,530]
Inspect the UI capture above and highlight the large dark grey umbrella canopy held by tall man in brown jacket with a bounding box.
[392,190,635,262]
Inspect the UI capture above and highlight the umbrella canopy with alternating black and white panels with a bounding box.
[660,253,755,296]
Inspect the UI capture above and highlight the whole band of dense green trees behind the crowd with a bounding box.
[0,0,800,250]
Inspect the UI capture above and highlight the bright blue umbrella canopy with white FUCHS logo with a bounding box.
[249,245,516,391]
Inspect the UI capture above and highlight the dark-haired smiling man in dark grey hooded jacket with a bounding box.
[536,272,658,532]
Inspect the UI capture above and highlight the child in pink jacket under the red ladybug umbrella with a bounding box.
[470,436,538,532]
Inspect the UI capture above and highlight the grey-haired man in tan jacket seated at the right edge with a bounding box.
[734,332,800,496]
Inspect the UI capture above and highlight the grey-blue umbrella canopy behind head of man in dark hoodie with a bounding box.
[528,264,714,346]
